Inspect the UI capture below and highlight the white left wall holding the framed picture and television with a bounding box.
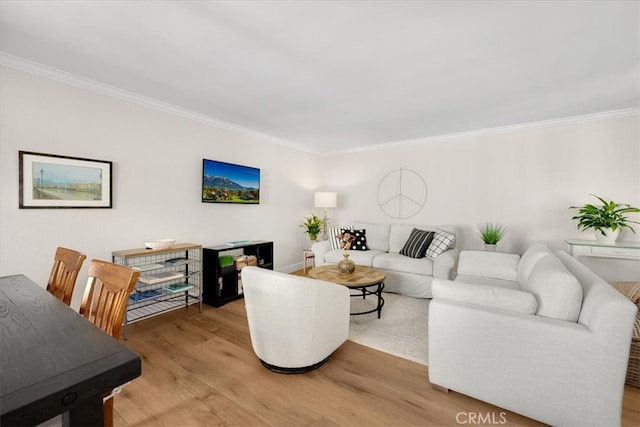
[0,67,322,306]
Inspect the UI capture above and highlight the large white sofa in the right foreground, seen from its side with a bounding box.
[429,244,637,426]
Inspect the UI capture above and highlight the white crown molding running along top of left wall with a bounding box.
[0,52,308,151]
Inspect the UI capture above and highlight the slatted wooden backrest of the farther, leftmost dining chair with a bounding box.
[47,248,87,305]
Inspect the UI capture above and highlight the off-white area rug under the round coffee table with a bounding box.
[349,292,431,365]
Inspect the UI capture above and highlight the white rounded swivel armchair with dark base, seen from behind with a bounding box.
[242,267,350,373]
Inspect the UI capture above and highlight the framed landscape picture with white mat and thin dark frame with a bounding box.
[18,151,111,209]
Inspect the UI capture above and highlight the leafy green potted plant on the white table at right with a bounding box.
[569,194,640,242]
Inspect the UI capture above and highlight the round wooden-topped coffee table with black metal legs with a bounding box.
[309,264,386,319]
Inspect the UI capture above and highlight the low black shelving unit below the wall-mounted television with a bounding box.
[202,240,273,307]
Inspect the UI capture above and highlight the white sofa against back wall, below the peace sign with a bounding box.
[311,221,458,298]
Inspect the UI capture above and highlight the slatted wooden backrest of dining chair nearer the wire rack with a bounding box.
[80,259,140,339]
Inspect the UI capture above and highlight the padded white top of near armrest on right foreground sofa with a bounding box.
[431,279,538,314]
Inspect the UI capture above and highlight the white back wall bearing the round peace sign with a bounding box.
[324,114,640,281]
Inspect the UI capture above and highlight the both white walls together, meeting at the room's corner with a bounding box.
[0,67,640,305]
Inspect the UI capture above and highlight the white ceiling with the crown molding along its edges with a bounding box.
[0,0,640,152]
